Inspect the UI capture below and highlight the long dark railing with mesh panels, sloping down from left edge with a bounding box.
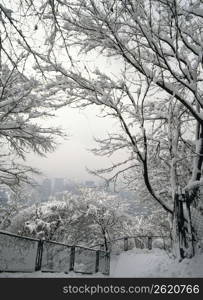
[0,231,110,275]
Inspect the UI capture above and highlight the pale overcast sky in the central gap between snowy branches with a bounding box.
[27,103,125,181]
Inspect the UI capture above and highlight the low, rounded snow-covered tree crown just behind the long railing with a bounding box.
[7,187,132,249]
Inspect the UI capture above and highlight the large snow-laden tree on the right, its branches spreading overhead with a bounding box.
[1,0,203,258]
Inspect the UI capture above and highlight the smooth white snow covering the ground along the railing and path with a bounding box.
[0,249,203,278]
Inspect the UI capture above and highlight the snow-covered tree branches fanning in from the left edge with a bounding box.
[0,65,61,187]
